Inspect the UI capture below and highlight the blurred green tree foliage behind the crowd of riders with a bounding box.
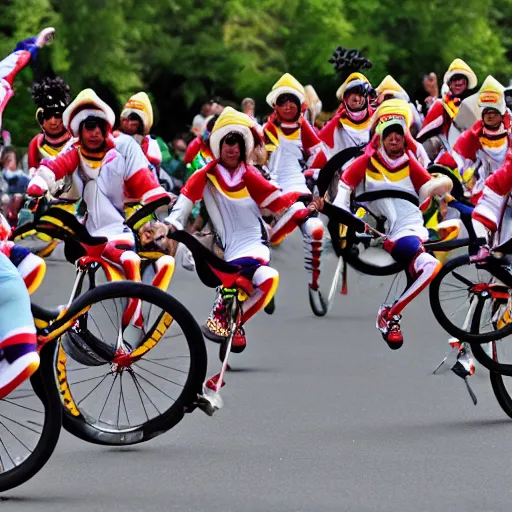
[0,0,512,145]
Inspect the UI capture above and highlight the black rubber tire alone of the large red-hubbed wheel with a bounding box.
[53,281,207,446]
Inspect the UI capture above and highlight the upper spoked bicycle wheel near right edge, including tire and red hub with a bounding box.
[429,255,512,343]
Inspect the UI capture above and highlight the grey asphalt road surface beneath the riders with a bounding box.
[0,236,512,512]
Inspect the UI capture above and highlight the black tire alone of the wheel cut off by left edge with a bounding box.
[0,341,62,492]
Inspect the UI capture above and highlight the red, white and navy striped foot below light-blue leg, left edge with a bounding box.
[0,343,39,399]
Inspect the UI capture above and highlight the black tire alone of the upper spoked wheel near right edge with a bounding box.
[429,254,512,342]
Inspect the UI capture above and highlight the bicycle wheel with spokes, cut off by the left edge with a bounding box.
[0,342,62,492]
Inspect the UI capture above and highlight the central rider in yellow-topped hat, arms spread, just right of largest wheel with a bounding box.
[140,107,308,352]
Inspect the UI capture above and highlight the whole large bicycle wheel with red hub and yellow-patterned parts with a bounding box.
[54,281,207,445]
